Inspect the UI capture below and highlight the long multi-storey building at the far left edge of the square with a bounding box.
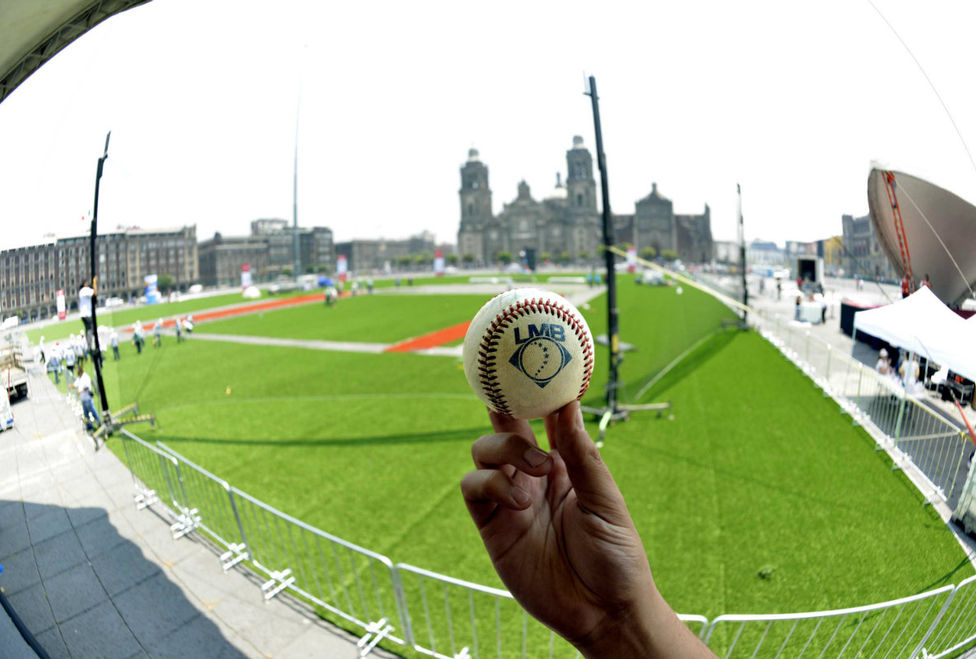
[0,226,199,320]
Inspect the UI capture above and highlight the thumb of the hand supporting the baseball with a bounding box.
[545,401,632,526]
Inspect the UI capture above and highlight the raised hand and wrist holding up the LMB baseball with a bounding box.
[461,401,713,657]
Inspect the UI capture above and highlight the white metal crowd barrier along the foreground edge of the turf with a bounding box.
[116,422,976,659]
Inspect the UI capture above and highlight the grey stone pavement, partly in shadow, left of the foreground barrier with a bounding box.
[0,368,395,659]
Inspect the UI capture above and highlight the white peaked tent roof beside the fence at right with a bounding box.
[854,286,976,380]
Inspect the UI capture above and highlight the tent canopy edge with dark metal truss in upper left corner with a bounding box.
[0,0,148,103]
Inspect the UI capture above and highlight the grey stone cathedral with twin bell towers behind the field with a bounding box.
[457,136,712,265]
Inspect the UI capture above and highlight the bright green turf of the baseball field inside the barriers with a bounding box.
[74,279,973,636]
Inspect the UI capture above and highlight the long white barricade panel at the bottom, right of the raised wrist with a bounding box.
[705,586,955,659]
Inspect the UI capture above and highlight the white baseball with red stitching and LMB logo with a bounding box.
[463,288,593,419]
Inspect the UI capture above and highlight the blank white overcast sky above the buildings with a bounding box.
[0,0,976,253]
